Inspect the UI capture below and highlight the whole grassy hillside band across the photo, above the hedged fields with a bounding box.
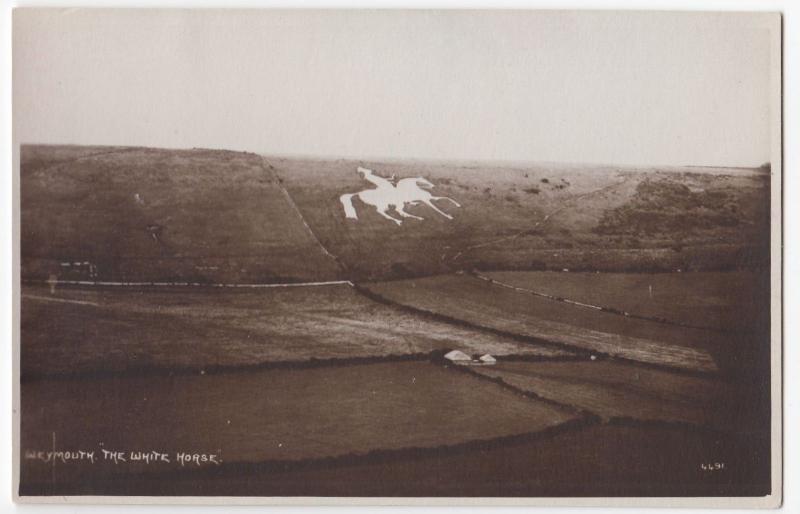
[20,146,769,282]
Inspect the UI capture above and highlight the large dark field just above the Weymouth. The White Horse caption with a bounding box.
[21,362,575,481]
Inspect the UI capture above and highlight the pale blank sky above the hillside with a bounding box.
[13,9,779,166]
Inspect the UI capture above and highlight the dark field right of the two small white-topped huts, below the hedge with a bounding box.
[470,360,769,434]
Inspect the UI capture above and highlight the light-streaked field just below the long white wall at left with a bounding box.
[21,285,565,377]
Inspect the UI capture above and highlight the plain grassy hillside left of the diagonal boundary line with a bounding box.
[20,146,338,282]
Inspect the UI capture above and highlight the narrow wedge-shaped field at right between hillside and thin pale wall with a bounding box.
[483,271,769,332]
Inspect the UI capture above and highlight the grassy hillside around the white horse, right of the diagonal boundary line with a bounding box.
[268,158,769,279]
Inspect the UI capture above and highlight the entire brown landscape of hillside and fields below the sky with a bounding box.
[20,146,770,496]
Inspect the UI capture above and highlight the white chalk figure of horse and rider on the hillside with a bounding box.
[339,167,461,225]
